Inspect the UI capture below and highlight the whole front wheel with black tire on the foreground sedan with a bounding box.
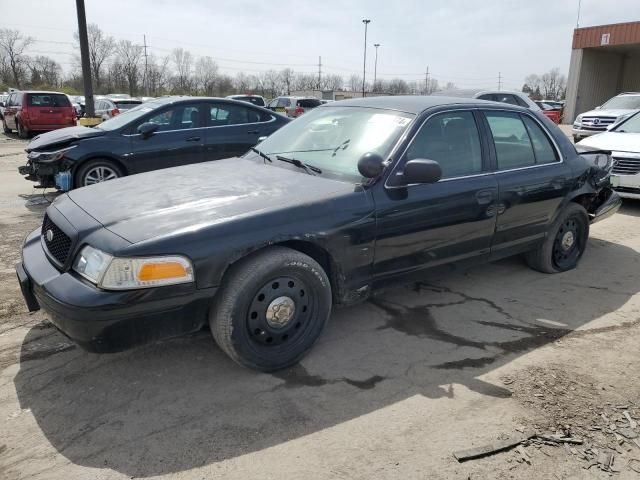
[209,247,332,372]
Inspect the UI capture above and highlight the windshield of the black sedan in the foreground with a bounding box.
[258,107,414,181]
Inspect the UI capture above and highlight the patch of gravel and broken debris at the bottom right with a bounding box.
[454,367,640,475]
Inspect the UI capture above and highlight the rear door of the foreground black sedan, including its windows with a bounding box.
[484,110,571,258]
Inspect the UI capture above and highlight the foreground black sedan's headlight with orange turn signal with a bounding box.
[73,246,193,290]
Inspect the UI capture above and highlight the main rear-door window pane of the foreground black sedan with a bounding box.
[485,112,536,170]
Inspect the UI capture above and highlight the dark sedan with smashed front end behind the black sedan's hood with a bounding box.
[19,97,288,190]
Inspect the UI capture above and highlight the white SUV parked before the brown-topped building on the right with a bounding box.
[571,92,640,143]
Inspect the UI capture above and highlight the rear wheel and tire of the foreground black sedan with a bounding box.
[525,203,589,273]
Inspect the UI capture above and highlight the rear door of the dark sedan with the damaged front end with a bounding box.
[205,102,274,160]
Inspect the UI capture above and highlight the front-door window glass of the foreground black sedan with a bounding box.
[406,112,482,178]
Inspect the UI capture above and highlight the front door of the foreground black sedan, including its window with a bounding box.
[374,110,498,277]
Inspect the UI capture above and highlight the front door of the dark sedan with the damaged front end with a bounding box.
[127,102,206,173]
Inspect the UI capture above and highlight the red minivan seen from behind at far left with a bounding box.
[2,90,77,138]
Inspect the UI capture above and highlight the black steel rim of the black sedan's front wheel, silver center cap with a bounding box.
[246,276,316,346]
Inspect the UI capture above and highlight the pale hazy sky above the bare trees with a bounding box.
[0,0,640,89]
